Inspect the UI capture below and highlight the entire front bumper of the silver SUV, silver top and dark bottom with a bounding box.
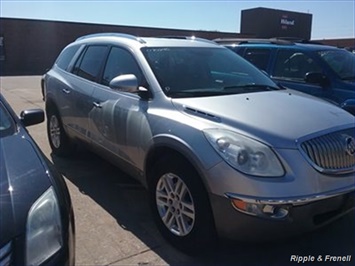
[204,145,355,241]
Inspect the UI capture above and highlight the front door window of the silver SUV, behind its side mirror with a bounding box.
[102,47,142,86]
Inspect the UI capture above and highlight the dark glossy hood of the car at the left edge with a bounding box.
[0,132,50,247]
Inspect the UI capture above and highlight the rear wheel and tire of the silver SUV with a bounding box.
[47,108,75,157]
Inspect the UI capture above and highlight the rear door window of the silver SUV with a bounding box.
[73,46,107,81]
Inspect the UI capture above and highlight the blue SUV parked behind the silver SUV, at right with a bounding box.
[215,39,355,115]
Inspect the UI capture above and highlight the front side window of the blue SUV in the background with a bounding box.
[272,50,322,81]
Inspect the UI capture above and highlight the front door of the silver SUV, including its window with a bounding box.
[89,47,150,167]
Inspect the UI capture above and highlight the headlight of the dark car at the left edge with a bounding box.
[26,187,62,265]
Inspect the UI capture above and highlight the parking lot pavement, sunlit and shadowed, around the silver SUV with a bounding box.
[0,76,355,265]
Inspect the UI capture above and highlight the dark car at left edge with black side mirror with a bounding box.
[0,95,75,265]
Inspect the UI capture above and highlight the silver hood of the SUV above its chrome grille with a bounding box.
[172,89,354,148]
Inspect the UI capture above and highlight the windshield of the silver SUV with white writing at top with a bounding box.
[143,47,280,98]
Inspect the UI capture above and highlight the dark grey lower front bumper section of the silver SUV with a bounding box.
[211,191,355,242]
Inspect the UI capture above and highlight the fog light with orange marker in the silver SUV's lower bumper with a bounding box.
[231,198,290,219]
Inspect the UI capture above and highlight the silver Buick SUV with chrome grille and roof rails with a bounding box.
[42,34,355,251]
